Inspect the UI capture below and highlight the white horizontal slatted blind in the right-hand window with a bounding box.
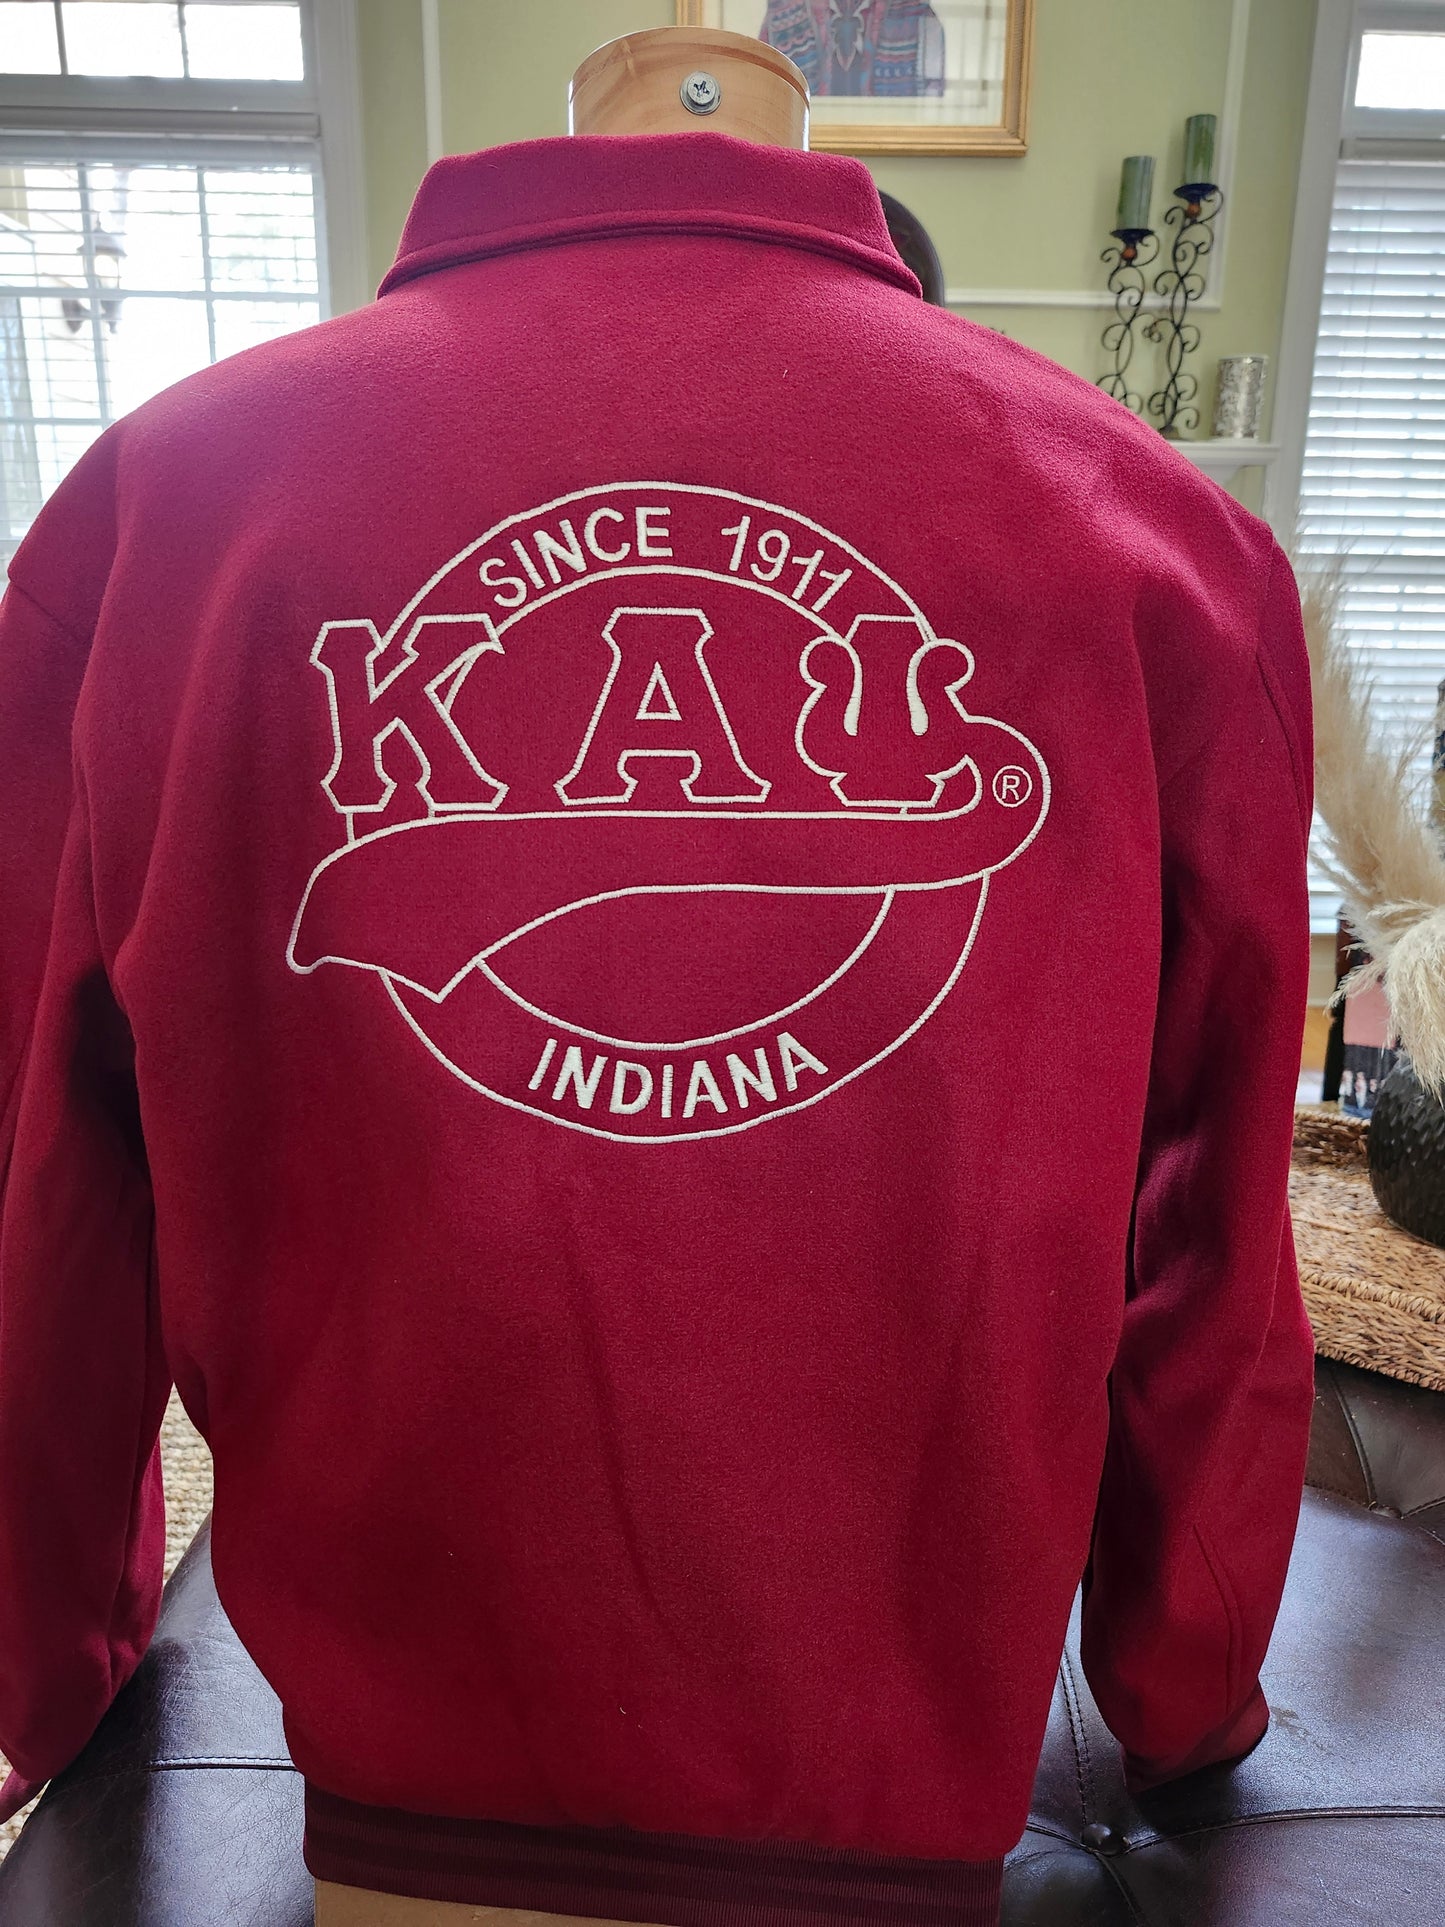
[1301,158,1445,929]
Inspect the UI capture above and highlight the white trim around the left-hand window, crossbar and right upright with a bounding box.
[0,0,372,314]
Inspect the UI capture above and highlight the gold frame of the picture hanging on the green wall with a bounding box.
[676,0,1033,156]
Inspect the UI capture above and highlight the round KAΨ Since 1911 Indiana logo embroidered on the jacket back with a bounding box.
[287,482,1048,1143]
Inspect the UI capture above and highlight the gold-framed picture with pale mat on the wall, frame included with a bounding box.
[676,0,1033,154]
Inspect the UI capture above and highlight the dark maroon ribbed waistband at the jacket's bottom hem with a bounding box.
[306,1784,1004,1927]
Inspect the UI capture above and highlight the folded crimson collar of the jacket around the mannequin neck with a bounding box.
[380,133,919,295]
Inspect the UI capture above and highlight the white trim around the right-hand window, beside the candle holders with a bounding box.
[1264,0,1445,543]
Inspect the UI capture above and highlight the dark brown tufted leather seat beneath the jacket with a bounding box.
[0,1362,1445,1927]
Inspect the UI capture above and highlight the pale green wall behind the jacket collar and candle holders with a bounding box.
[358,0,1316,466]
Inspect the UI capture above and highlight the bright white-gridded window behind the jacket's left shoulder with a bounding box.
[0,0,358,565]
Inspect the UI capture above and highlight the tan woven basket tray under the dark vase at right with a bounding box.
[1289,1104,1445,1391]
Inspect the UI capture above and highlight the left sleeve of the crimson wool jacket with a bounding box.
[0,584,170,1819]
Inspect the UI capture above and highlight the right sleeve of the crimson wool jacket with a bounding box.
[1083,549,1314,1792]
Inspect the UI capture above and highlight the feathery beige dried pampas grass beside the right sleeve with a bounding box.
[1301,565,1445,1098]
